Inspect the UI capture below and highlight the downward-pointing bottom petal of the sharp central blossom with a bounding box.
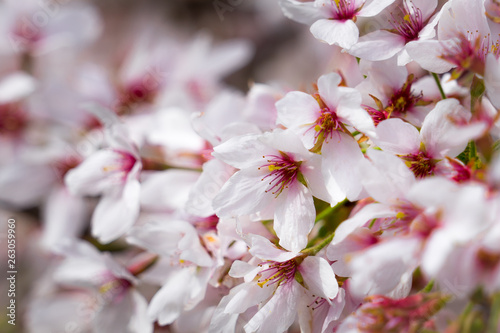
[274,182,316,252]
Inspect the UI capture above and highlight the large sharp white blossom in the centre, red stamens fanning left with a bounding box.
[213,130,328,251]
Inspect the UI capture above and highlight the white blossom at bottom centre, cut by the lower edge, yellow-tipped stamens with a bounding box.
[209,235,338,332]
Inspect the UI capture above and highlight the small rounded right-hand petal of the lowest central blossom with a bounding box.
[298,256,339,300]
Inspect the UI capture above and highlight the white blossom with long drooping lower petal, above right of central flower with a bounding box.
[276,73,374,205]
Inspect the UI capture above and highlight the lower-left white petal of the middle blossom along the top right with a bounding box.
[349,30,405,61]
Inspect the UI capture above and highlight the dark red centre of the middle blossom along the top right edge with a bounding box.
[390,1,424,43]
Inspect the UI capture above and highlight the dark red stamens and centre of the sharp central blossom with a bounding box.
[259,151,302,197]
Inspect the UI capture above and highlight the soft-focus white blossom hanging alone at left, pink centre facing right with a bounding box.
[65,125,142,243]
